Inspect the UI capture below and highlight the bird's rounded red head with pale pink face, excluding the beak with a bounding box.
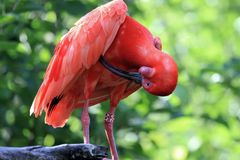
[138,52,178,96]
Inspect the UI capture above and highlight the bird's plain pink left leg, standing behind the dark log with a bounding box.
[81,100,90,144]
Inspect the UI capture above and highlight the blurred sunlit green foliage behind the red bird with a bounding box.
[0,0,240,160]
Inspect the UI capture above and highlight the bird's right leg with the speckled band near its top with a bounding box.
[104,107,119,160]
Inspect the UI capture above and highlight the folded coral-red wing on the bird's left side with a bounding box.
[30,0,127,117]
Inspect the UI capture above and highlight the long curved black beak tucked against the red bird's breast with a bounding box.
[99,56,142,84]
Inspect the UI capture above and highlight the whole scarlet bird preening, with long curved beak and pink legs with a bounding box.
[30,0,178,160]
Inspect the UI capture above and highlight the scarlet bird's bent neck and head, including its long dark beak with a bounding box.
[100,16,178,96]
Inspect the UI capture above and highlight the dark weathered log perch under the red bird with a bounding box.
[0,144,108,160]
